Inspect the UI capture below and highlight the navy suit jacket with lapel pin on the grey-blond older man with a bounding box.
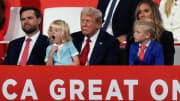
[72,30,120,65]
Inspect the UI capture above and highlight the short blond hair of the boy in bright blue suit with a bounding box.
[134,19,155,37]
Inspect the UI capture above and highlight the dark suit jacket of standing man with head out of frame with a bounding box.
[97,0,139,37]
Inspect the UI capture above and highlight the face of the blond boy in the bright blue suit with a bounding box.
[133,26,150,43]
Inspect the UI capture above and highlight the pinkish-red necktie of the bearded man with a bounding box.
[20,38,31,65]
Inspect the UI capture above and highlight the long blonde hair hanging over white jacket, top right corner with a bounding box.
[164,0,174,17]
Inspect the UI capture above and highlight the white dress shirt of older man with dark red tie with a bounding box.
[81,30,100,65]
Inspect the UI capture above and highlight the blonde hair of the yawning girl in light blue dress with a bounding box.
[48,20,72,44]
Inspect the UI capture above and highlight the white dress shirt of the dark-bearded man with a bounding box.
[17,31,40,65]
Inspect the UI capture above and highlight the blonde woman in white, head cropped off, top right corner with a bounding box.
[159,0,180,43]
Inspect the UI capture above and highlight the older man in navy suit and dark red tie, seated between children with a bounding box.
[72,7,120,65]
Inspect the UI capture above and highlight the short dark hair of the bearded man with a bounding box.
[20,6,41,18]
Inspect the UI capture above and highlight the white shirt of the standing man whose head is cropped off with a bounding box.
[102,0,120,35]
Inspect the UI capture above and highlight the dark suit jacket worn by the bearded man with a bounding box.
[3,34,49,65]
